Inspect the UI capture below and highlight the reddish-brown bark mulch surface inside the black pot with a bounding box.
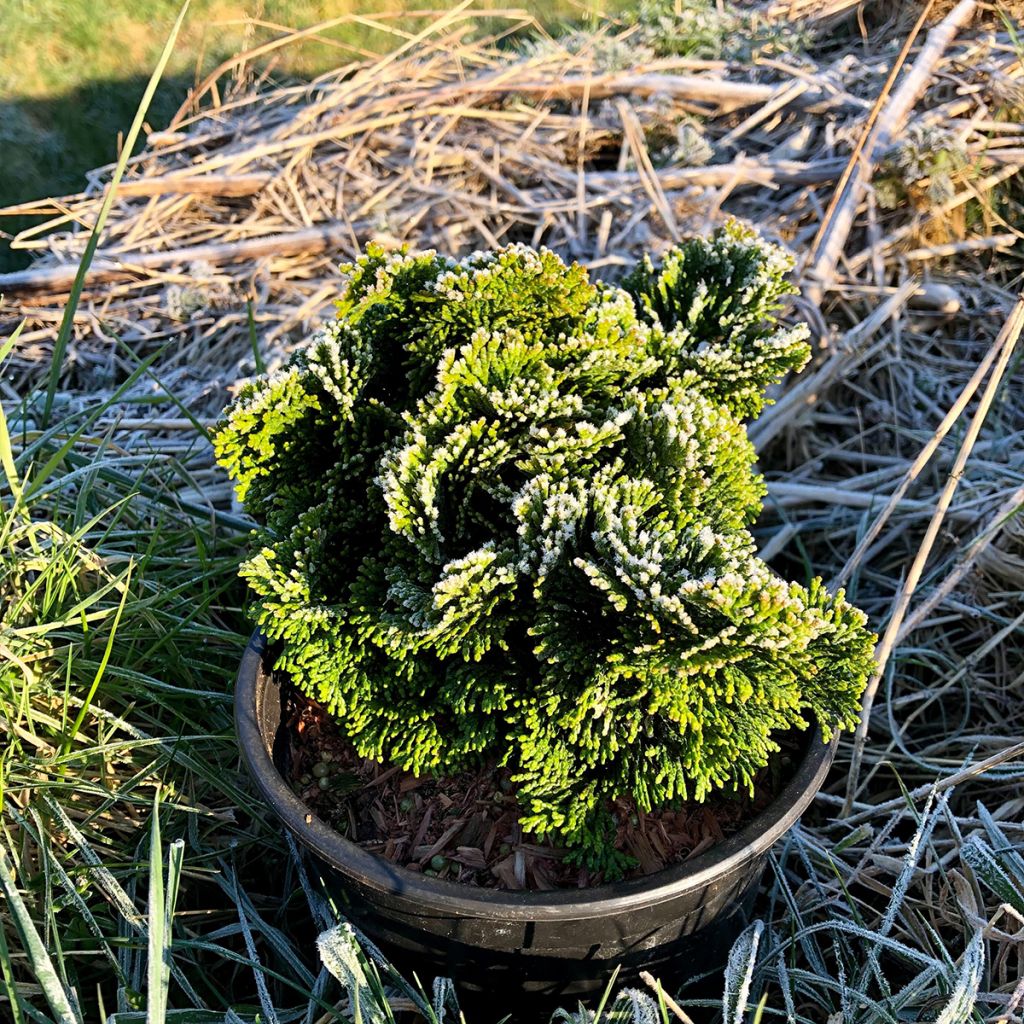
[282,682,801,890]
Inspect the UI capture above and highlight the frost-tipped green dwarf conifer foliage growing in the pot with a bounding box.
[215,223,873,874]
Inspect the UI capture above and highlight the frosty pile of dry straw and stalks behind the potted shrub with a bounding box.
[0,0,1024,1021]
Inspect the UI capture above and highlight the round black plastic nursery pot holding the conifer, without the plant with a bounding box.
[234,634,837,1024]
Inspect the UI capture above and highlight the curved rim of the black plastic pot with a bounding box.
[234,631,839,921]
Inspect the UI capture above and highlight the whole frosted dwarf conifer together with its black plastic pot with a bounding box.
[215,222,873,1010]
